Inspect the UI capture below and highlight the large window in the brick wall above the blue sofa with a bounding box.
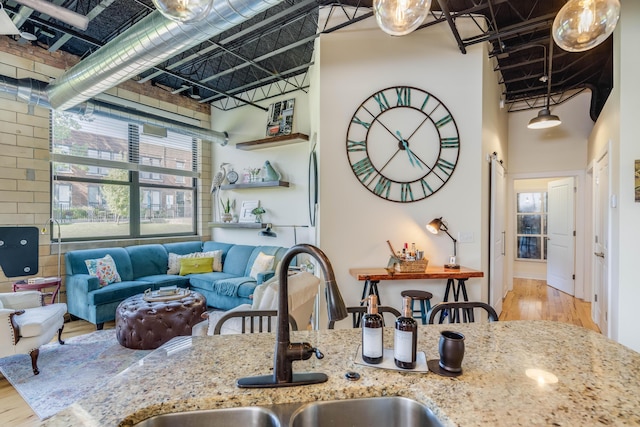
[51,112,198,240]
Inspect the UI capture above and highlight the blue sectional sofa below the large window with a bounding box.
[65,241,287,329]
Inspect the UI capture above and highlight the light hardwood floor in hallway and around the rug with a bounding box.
[0,279,600,427]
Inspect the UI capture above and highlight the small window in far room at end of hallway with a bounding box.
[516,192,547,261]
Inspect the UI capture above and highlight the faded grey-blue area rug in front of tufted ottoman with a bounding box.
[0,329,150,419]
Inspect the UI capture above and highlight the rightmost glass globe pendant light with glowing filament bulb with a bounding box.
[552,0,620,52]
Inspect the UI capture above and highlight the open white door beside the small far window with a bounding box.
[547,177,575,295]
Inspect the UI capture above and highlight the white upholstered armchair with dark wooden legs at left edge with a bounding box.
[0,291,67,375]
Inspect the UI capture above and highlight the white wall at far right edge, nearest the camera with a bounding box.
[589,1,640,351]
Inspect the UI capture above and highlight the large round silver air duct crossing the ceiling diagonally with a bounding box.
[47,0,282,110]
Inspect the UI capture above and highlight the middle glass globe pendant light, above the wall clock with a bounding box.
[373,0,431,36]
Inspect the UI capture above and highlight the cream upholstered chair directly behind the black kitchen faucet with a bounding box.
[192,272,320,336]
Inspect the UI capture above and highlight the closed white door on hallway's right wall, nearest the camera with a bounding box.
[593,154,609,336]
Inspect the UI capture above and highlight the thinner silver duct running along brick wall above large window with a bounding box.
[0,75,229,145]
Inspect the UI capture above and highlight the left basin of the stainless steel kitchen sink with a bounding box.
[136,406,280,427]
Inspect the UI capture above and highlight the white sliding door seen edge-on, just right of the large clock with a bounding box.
[489,157,507,315]
